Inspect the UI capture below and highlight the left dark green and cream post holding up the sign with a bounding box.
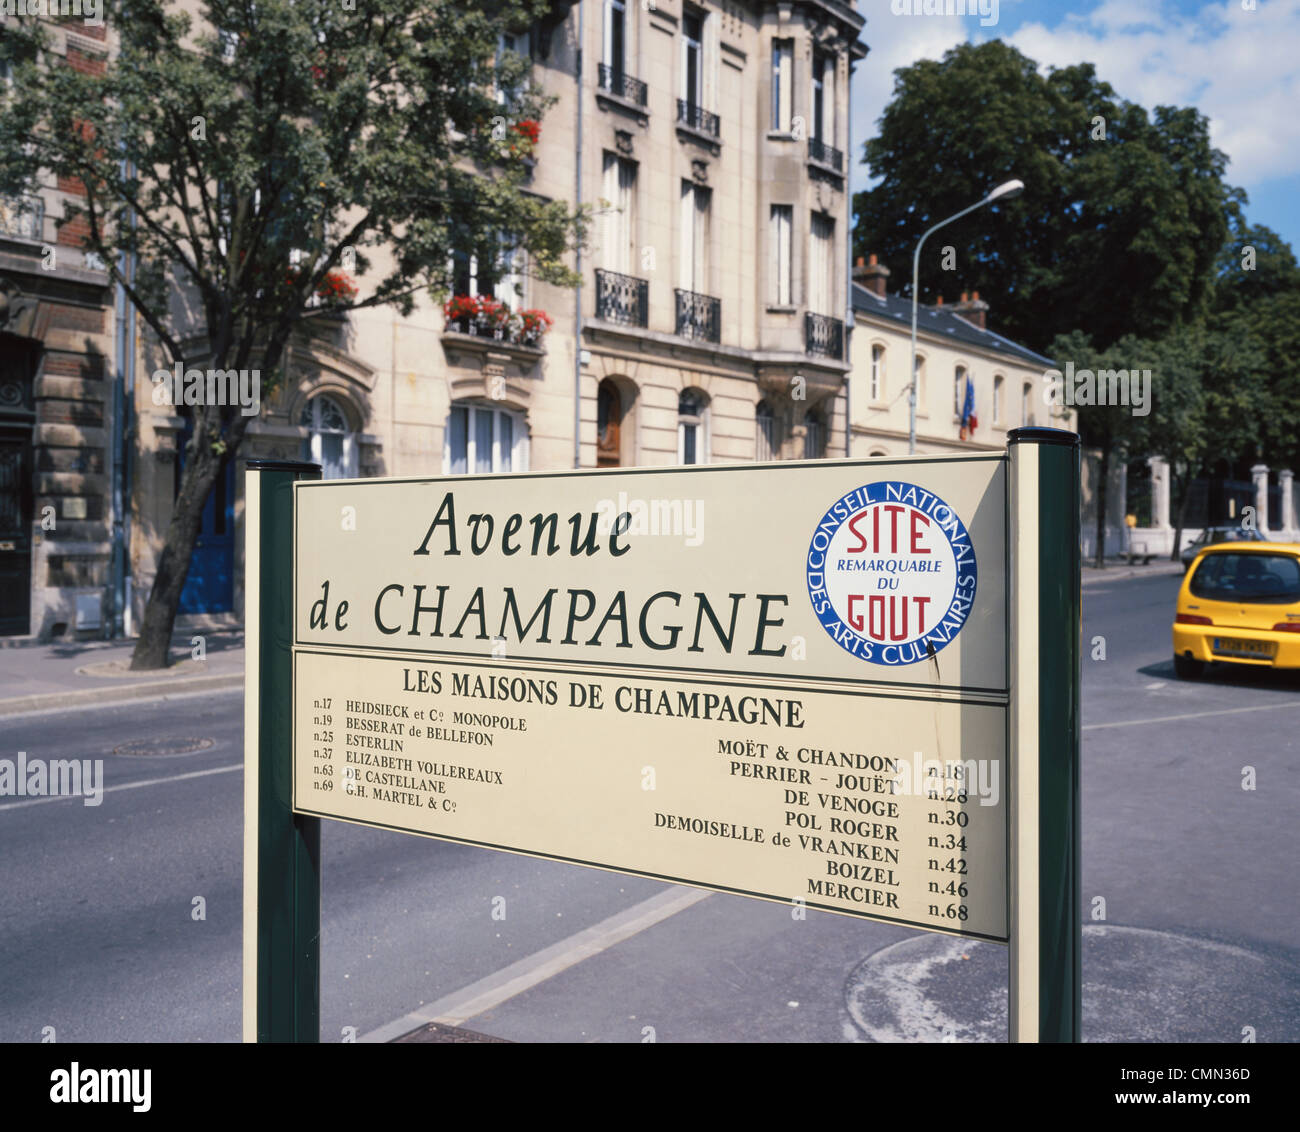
[243,460,321,1042]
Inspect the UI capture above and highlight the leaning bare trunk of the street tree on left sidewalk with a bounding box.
[131,426,226,672]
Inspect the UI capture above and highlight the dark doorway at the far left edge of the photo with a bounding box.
[0,334,40,637]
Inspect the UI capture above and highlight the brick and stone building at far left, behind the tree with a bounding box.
[0,18,125,636]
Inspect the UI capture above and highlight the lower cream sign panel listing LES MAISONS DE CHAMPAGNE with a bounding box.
[294,649,1006,940]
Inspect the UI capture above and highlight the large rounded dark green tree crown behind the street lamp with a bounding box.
[854,40,1240,351]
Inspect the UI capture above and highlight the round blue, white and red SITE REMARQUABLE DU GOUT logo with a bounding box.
[807,480,976,664]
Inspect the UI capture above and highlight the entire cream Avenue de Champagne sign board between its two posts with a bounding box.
[293,454,1009,940]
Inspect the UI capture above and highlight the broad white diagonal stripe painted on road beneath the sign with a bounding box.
[358,885,712,1042]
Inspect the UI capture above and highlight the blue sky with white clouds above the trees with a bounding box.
[853,0,1300,253]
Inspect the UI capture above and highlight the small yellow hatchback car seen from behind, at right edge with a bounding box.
[1174,542,1300,680]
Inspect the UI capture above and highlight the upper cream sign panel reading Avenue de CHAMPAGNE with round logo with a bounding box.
[294,456,1006,693]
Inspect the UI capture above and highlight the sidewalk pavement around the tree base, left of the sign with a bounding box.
[0,629,244,716]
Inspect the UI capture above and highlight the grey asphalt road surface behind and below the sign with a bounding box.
[0,577,1300,1041]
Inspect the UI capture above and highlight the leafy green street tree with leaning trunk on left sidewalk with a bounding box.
[0,0,584,668]
